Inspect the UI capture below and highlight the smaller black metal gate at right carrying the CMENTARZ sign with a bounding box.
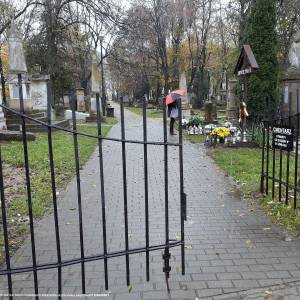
[260,90,300,209]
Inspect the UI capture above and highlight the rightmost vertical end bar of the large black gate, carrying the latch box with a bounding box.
[178,99,187,275]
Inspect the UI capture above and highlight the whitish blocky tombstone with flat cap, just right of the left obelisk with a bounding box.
[30,74,50,111]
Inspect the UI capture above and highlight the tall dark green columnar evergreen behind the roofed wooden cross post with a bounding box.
[245,0,279,116]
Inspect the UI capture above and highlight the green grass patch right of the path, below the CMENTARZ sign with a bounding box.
[211,149,300,230]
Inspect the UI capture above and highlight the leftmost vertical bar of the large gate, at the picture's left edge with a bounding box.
[0,147,13,300]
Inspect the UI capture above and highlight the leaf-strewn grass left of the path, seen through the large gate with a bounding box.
[0,118,117,257]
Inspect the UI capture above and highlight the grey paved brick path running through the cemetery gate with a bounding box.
[0,106,300,300]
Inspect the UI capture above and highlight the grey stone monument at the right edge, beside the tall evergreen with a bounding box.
[281,32,300,115]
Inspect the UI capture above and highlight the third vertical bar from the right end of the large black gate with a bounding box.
[143,97,150,281]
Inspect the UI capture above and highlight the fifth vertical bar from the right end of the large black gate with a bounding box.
[96,93,108,290]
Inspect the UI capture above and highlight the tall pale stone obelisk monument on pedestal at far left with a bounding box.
[8,22,33,111]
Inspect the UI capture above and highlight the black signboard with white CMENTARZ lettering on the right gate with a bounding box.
[272,126,294,152]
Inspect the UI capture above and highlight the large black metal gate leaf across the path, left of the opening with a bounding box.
[0,75,186,299]
